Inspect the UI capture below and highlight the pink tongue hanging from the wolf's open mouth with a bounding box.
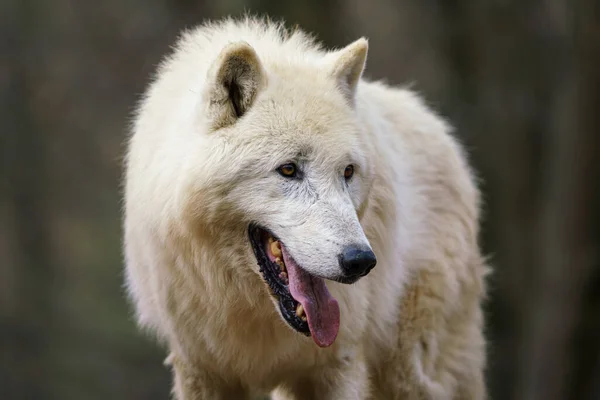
[281,246,340,347]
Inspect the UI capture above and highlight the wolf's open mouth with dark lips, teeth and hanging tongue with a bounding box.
[248,224,340,347]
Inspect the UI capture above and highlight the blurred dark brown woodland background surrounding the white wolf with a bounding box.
[0,0,600,400]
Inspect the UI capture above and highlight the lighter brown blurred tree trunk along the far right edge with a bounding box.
[517,0,600,400]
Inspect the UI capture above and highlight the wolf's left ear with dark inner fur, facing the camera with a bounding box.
[205,42,265,129]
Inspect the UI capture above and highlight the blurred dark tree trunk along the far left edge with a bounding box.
[2,0,52,399]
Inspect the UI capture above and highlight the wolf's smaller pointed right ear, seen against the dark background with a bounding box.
[329,37,369,103]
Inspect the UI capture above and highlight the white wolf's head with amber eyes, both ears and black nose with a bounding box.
[184,39,376,343]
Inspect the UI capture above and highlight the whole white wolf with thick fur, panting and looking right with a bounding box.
[124,18,487,400]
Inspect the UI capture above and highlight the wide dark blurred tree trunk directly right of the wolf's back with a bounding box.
[439,1,548,399]
